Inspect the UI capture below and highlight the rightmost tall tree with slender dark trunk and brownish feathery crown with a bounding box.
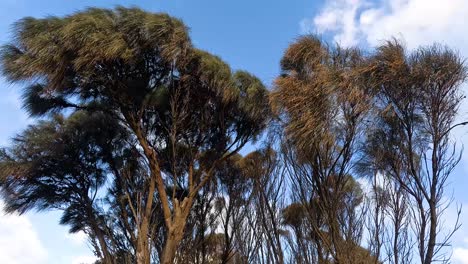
[362,40,467,264]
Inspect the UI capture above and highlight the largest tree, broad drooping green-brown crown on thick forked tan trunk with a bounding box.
[1,7,269,263]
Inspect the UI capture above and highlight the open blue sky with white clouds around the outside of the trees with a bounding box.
[0,0,468,264]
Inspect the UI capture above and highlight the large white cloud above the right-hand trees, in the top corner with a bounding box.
[301,0,468,50]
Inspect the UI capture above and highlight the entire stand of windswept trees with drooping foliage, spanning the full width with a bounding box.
[0,7,467,264]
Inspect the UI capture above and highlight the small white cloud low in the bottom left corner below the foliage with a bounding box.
[0,201,48,264]
